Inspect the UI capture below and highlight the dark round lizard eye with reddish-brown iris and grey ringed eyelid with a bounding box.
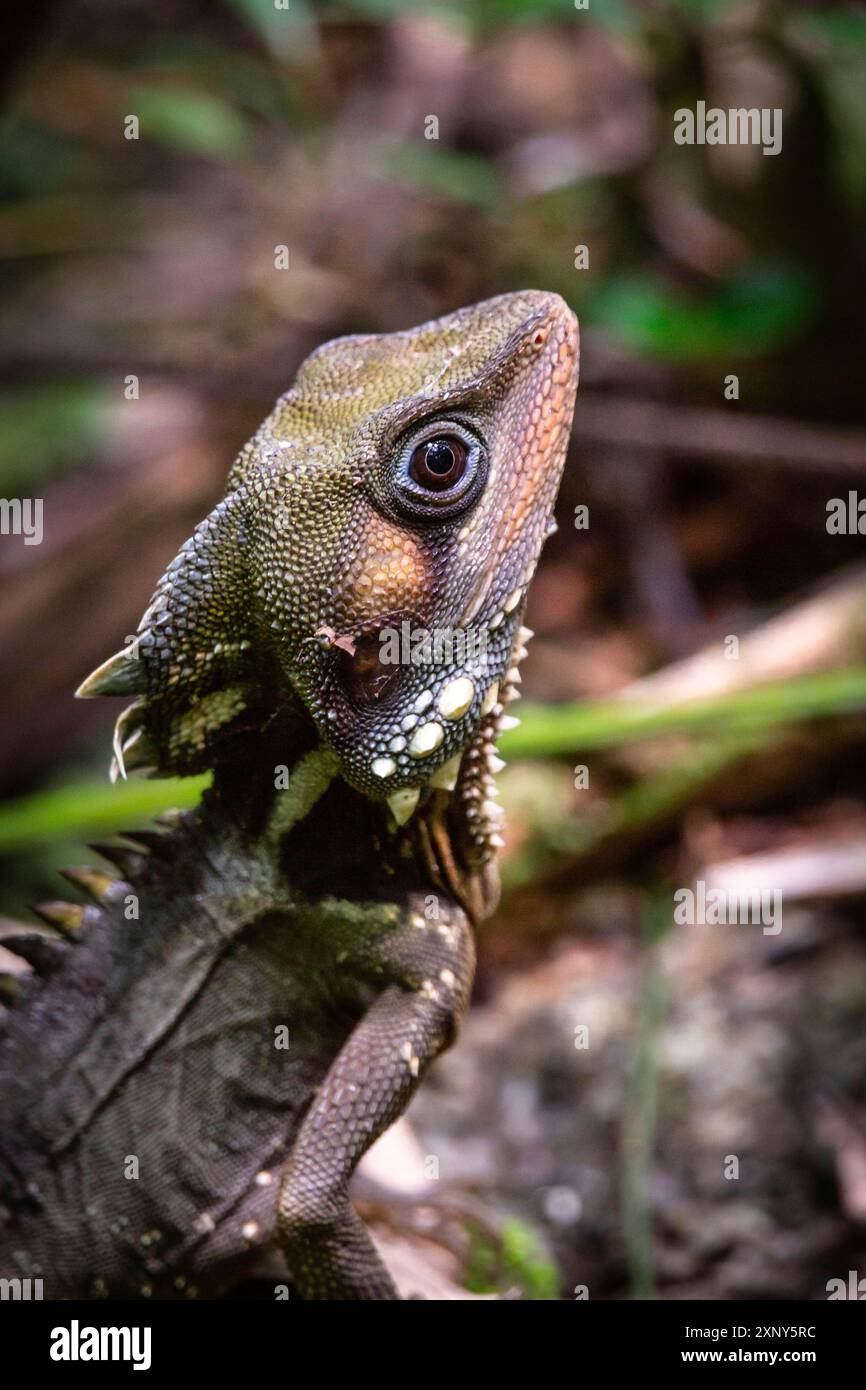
[392,420,487,521]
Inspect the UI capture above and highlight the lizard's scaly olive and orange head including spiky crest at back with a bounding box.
[81,291,577,821]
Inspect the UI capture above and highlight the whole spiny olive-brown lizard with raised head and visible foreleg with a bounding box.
[0,291,578,1300]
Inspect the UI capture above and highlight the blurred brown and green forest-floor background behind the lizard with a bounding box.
[0,0,866,1298]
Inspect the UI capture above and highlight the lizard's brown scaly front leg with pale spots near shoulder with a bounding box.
[278,906,475,1300]
